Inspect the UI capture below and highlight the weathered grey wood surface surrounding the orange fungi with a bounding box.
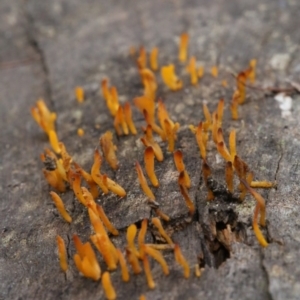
[0,0,300,299]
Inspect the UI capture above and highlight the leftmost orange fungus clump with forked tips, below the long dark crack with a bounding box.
[30,99,56,134]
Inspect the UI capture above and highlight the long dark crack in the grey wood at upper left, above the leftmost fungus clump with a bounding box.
[23,2,55,110]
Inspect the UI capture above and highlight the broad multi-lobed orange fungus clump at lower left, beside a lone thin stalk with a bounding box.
[73,236,101,281]
